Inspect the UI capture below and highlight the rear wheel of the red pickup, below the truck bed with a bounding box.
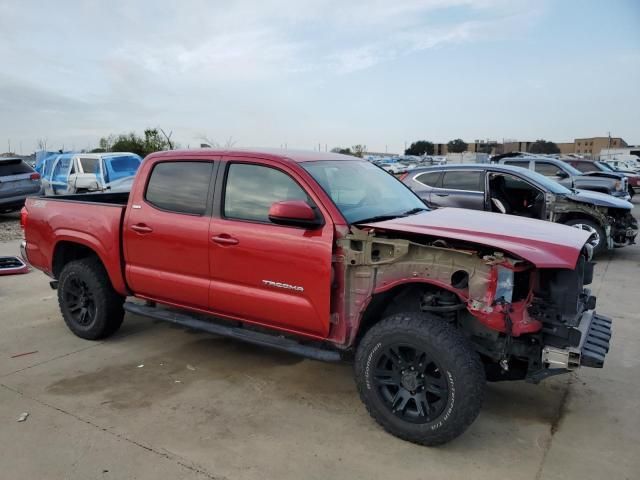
[58,258,124,340]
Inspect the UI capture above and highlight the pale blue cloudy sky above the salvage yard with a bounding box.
[0,0,640,153]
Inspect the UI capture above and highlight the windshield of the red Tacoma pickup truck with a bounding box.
[301,160,427,223]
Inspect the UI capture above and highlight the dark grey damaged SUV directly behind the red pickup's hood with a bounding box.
[401,163,638,253]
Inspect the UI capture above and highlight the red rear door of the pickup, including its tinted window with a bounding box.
[123,160,217,309]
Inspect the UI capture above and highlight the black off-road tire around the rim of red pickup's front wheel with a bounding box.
[355,312,485,446]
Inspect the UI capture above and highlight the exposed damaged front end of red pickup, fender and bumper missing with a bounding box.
[334,221,611,382]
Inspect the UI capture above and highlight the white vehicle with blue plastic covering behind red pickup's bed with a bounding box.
[39,152,142,195]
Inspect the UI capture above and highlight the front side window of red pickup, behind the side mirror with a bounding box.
[223,163,311,223]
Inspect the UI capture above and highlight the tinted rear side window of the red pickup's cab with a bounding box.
[145,162,213,215]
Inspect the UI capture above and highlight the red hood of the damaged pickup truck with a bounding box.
[367,208,589,269]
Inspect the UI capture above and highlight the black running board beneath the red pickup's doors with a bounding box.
[124,302,342,362]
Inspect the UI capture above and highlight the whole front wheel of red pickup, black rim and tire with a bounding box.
[355,312,485,446]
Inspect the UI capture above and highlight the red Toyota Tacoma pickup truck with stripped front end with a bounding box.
[22,150,611,445]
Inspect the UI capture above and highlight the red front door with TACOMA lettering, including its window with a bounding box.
[209,158,333,337]
